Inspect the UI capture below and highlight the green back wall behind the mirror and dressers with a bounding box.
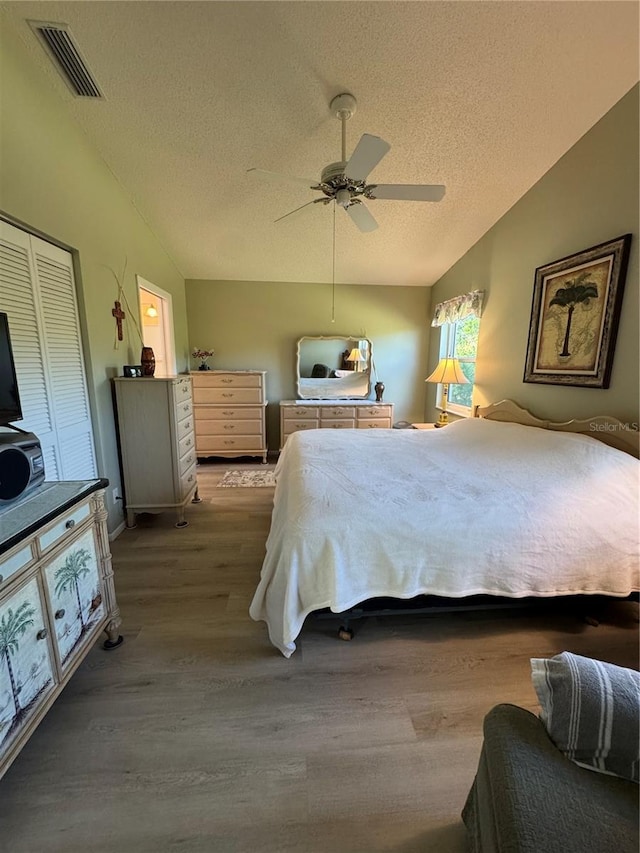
[186,280,431,450]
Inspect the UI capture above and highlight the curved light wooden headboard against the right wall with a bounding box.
[474,400,640,459]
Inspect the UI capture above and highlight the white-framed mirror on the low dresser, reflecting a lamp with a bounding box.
[297,335,371,400]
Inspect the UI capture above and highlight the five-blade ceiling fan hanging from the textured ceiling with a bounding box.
[247,92,445,231]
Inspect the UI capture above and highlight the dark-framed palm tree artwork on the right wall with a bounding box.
[524,234,631,388]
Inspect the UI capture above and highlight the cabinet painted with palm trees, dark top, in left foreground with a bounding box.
[0,480,122,776]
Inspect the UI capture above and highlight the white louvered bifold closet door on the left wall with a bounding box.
[0,222,96,480]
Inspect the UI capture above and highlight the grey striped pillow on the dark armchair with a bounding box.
[531,652,640,782]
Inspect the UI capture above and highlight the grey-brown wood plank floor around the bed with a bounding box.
[0,463,638,853]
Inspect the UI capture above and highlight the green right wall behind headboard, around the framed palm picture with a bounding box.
[428,86,640,422]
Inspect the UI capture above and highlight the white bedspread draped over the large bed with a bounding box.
[250,419,640,657]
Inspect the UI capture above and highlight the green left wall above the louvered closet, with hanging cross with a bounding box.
[0,16,188,530]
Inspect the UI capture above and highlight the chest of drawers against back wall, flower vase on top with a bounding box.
[191,370,267,462]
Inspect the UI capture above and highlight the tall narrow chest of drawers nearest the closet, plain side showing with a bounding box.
[113,376,199,527]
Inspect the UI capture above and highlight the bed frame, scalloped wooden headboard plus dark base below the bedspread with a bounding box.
[322,400,640,640]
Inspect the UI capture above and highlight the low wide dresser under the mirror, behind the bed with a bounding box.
[280,400,393,450]
